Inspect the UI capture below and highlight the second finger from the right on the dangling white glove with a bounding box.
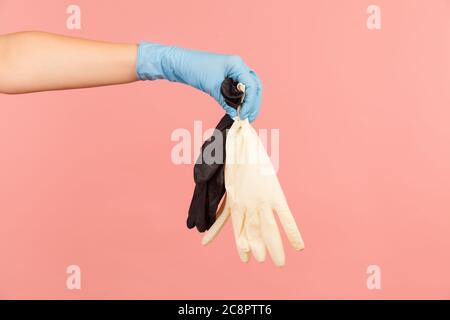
[260,206,285,267]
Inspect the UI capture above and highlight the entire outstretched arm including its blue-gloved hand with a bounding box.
[0,31,262,121]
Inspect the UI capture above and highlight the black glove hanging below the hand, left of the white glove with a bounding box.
[187,115,233,232]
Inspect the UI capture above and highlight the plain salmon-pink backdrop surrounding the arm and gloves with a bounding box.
[0,0,450,299]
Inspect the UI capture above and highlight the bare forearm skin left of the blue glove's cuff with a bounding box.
[0,31,138,94]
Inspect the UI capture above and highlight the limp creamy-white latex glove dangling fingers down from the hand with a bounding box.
[202,118,304,266]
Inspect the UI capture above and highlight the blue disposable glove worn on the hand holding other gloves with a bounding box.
[136,42,262,121]
